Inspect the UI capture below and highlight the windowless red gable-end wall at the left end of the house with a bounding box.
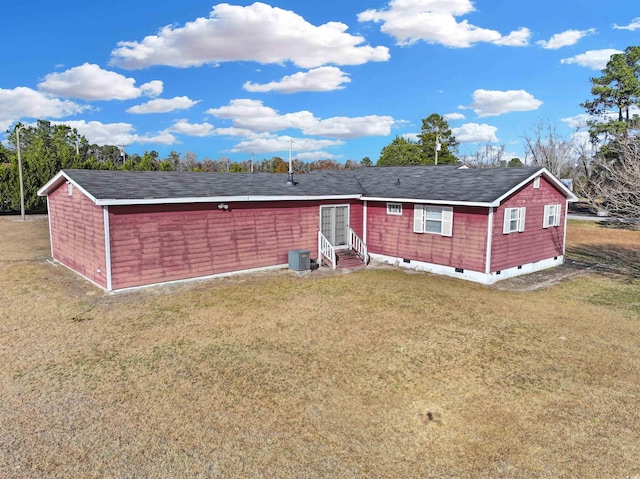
[49,183,107,288]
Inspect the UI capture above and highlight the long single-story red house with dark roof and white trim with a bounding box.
[38,166,577,291]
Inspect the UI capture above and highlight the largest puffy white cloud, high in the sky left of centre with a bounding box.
[111,2,389,69]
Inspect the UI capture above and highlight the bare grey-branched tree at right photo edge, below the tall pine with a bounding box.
[584,138,640,218]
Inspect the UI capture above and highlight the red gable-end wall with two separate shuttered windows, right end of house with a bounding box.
[491,177,566,272]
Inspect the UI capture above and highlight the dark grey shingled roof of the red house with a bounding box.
[43,165,556,203]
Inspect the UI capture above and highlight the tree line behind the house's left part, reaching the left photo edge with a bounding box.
[0,120,372,213]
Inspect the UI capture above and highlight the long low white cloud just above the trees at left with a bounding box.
[54,120,177,145]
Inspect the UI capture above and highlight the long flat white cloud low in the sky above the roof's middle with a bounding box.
[207,99,395,138]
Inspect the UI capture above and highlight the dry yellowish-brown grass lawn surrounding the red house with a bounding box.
[0,217,640,479]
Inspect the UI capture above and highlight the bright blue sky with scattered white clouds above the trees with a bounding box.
[0,0,640,162]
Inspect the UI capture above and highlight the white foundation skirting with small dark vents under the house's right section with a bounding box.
[369,253,564,285]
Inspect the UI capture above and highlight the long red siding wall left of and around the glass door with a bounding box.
[109,200,362,289]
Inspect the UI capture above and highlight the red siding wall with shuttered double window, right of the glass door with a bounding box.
[367,201,488,272]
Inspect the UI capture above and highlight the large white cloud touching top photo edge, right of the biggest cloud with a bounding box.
[358,0,530,48]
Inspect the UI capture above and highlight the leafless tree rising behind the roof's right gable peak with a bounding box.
[524,122,575,178]
